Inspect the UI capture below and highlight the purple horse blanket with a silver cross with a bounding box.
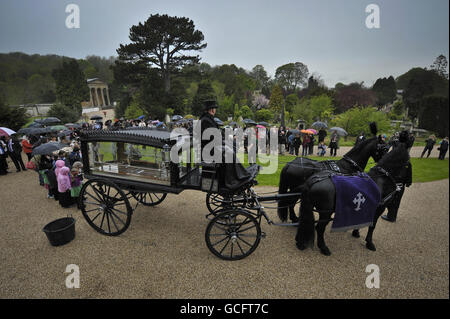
[331,173,381,232]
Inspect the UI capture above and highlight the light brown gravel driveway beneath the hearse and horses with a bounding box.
[0,160,449,299]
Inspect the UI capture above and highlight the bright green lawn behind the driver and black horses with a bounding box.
[251,155,449,186]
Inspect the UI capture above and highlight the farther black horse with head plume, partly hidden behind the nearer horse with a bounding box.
[278,122,388,223]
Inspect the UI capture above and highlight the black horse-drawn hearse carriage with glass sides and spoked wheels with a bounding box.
[79,128,299,260]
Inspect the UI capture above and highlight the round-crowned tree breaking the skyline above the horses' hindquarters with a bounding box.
[275,62,309,92]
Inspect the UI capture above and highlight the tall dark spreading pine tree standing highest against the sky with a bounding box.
[117,14,207,93]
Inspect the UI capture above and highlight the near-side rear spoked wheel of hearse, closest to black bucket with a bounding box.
[79,179,133,236]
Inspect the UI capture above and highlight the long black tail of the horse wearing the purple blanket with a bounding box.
[295,193,314,249]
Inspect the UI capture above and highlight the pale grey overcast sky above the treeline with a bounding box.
[0,0,449,86]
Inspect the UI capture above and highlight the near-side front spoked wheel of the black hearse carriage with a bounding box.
[205,209,261,260]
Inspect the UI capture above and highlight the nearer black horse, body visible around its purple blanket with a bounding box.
[295,143,410,256]
